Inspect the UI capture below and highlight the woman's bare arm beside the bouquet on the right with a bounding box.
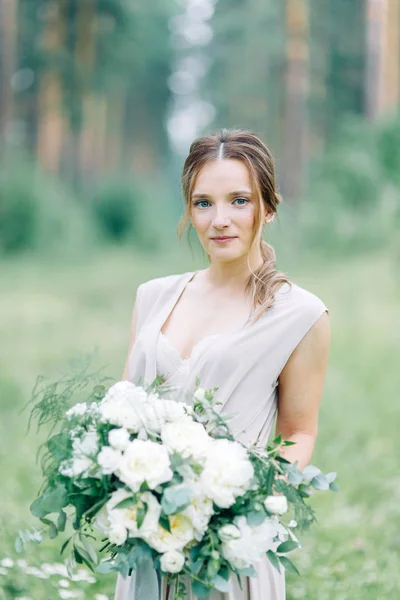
[276,312,330,469]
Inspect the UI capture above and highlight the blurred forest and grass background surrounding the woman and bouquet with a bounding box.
[0,0,400,600]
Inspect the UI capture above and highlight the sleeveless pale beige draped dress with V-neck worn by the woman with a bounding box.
[114,271,328,600]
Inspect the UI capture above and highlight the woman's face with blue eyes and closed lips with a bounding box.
[190,159,266,262]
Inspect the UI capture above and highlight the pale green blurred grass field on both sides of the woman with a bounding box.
[0,250,400,600]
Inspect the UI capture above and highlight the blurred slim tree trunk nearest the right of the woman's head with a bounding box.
[282,0,309,199]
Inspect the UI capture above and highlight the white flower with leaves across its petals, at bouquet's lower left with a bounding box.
[106,488,161,537]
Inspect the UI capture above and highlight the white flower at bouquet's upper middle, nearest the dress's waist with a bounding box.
[161,417,211,460]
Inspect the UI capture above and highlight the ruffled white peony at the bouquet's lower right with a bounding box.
[221,516,277,569]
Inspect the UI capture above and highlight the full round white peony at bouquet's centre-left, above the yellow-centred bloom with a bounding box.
[119,440,173,492]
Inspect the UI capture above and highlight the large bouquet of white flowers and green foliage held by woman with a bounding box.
[17,364,338,600]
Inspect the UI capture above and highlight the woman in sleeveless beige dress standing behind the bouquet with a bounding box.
[115,130,330,600]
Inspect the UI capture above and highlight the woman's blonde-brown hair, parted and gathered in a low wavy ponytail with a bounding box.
[177,129,290,321]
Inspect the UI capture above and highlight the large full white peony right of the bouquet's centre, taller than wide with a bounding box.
[200,439,254,508]
